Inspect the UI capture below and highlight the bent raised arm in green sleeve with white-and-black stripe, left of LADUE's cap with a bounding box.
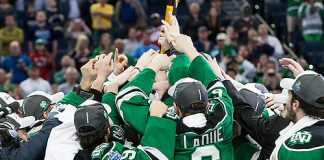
[115,52,171,134]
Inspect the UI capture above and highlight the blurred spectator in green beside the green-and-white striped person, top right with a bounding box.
[287,0,303,43]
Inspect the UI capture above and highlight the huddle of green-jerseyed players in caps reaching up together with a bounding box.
[0,13,324,160]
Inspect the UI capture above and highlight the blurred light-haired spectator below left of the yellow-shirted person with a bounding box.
[70,35,90,69]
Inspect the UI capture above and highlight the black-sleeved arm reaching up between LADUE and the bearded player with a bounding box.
[223,80,290,157]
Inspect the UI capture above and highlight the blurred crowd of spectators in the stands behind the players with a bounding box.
[0,0,324,99]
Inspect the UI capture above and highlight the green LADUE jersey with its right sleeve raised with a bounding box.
[175,56,234,160]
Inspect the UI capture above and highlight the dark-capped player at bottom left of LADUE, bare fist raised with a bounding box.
[74,100,176,160]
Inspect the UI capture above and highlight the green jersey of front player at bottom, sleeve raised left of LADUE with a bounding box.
[91,117,176,160]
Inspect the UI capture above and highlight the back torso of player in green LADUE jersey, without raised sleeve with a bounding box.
[174,99,234,160]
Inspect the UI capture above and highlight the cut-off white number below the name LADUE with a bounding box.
[191,146,220,160]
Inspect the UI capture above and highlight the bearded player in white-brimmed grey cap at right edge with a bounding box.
[270,71,324,160]
